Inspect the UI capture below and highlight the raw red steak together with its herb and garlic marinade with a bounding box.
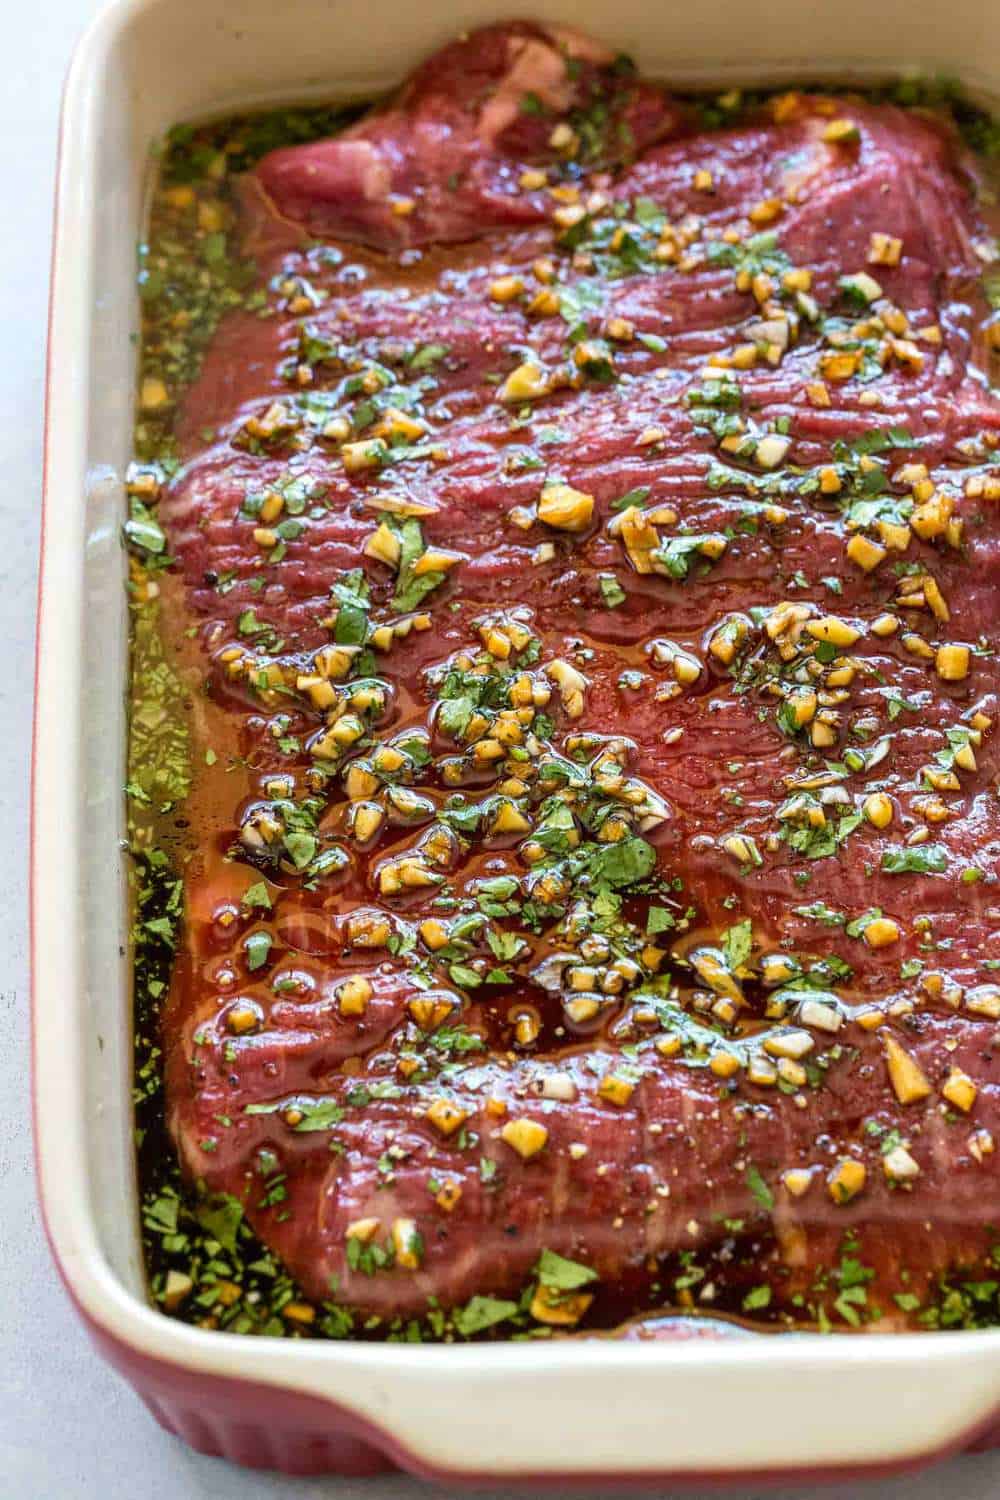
[124,23,1000,1340]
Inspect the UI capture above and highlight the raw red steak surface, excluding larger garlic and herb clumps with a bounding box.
[154,24,1000,1338]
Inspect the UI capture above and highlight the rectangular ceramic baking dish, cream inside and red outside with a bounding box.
[31,0,1000,1484]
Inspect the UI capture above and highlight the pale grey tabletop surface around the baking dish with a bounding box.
[0,0,1000,1500]
